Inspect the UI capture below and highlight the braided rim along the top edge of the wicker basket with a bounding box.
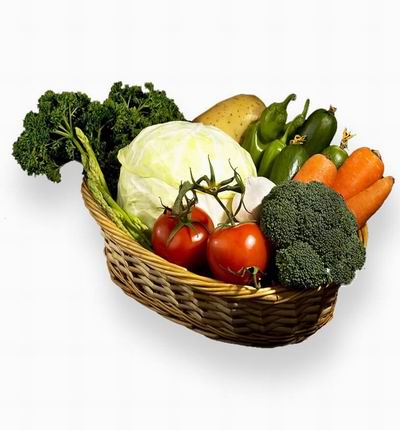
[81,178,368,303]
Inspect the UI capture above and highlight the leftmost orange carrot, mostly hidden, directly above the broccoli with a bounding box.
[293,154,337,187]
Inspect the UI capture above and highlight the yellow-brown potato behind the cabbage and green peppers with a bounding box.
[193,94,266,143]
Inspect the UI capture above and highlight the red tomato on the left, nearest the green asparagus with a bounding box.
[151,207,214,270]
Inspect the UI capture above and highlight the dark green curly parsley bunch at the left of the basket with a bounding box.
[13,82,184,196]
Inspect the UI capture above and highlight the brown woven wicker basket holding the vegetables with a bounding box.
[82,182,368,347]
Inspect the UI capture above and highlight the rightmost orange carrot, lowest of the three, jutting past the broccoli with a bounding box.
[346,176,394,228]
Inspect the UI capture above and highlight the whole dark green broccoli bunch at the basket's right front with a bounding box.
[260,181,365,288]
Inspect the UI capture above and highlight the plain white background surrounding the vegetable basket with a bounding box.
[0,0,400,430]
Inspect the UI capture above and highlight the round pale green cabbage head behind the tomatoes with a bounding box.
[118,121,257,228]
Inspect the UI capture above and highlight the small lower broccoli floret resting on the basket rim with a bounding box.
[275,242,330,288]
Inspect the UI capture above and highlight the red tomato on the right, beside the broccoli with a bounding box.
[207,223,271,285]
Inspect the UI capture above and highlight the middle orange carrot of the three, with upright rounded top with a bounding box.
[332,147,384,200]
